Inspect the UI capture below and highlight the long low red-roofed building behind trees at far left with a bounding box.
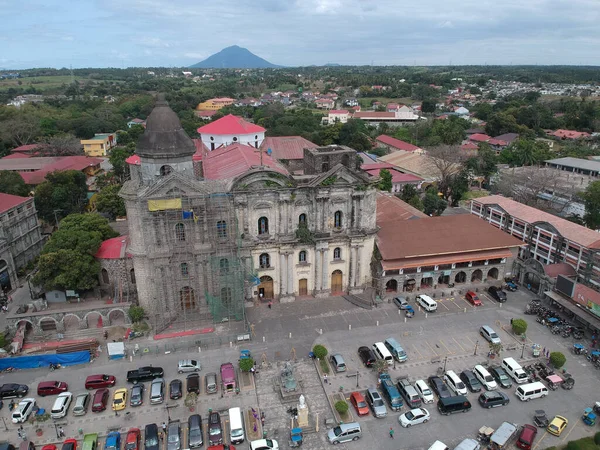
[0,153,102,186]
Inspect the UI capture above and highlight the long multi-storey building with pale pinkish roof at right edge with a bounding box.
[471,195,600,293]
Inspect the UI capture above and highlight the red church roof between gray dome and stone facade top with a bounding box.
[203,144,288,180]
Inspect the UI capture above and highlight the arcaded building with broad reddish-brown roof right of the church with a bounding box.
[373,193,523,296]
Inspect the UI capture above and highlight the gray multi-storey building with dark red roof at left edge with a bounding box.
[0,193,44,293]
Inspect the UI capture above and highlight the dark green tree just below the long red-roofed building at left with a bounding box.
[35,170,87,223]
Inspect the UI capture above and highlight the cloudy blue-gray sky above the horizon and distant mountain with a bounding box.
[0,0,600,68]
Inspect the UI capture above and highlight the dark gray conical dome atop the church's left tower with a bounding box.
[135,94,196,158]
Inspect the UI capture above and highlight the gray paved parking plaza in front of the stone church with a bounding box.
[0,284,600,450]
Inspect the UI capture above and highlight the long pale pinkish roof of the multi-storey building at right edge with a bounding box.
[472,195,600,249]
